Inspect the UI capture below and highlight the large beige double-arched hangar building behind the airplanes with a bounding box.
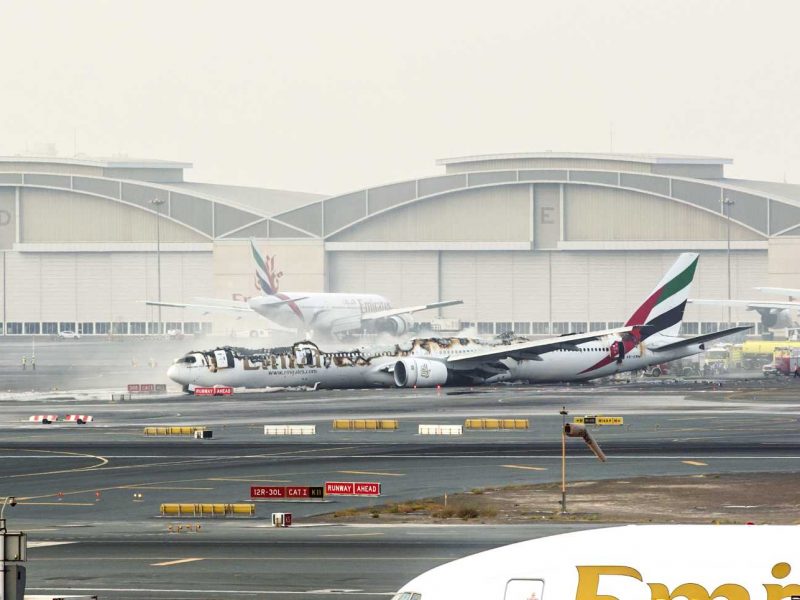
[0,152,800,335]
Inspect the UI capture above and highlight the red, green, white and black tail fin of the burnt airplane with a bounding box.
[625,252,700,336]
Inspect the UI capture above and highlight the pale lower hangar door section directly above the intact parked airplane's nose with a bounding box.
[328,252,439,312]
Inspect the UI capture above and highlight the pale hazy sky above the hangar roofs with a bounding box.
[0,0,800,193]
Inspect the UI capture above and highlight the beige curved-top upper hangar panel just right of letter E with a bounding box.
[564,185,764,241]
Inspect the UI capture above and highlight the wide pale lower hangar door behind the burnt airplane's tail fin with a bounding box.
[418,251,767,323]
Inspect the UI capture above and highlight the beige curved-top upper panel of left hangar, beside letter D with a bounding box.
[20,188,207,243]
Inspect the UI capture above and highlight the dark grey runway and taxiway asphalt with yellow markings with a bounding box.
[0,352,800,598]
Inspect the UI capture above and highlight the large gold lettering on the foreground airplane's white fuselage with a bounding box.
[575,563,800,600]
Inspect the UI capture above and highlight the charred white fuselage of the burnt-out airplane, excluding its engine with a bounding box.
[167,334,703,389]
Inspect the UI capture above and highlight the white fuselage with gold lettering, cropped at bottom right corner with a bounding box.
[394,525,800,600]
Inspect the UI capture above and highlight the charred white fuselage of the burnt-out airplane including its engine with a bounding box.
[168,335,703,389]
